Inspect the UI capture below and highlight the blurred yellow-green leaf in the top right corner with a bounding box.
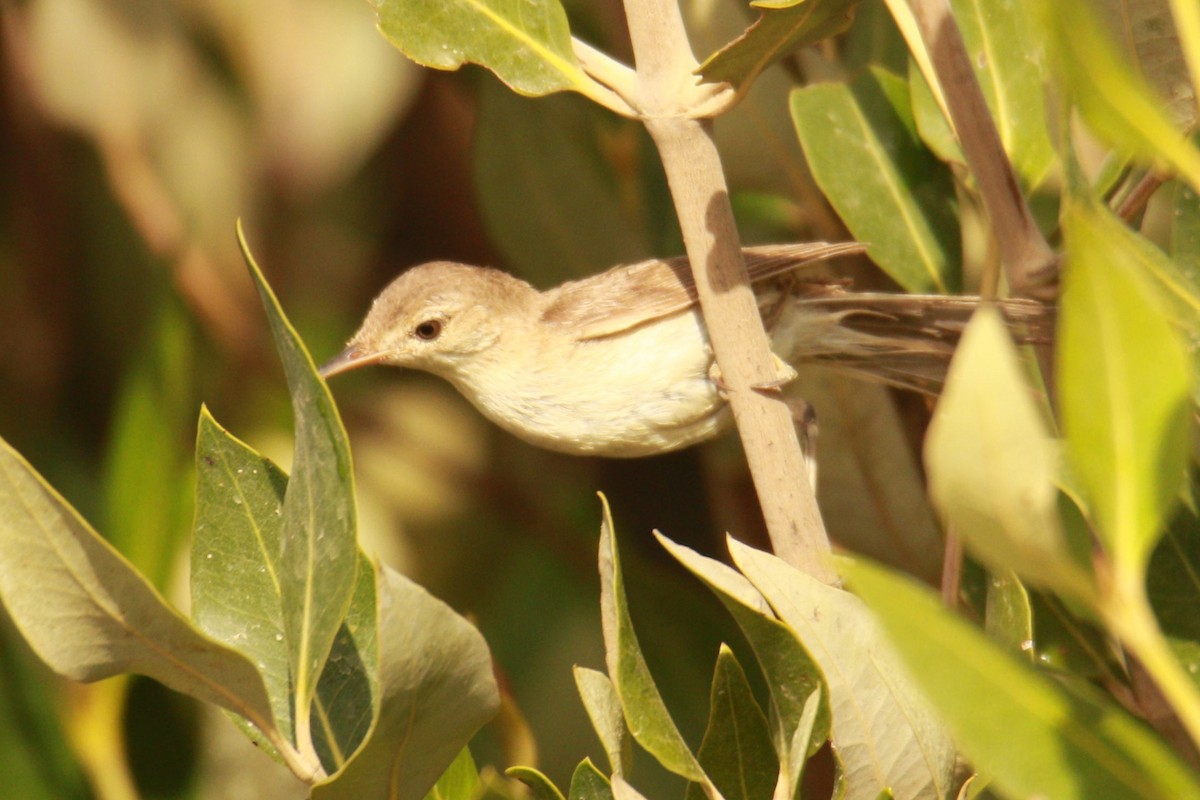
[1036,0,1200,190]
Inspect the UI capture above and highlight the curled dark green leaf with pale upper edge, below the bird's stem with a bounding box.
[655,534,830,796]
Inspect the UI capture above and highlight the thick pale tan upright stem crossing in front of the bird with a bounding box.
[625,0,836,583]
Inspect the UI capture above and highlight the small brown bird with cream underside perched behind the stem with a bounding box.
[322,242,1052,457]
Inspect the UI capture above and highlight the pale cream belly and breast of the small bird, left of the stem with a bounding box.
[460,314,728,457]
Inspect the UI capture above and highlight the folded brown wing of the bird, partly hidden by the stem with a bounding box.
[541,242,866,339]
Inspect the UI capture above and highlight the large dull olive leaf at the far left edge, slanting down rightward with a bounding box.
[0,439,274,732]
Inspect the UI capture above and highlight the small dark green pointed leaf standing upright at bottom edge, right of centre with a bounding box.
[686,644,779,800]
